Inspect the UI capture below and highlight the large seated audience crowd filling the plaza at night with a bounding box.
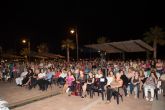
[0,59,165,103]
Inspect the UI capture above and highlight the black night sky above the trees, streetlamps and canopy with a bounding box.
[0,0,165,53]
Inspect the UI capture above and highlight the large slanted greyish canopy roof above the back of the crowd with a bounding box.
[85,40,153,53]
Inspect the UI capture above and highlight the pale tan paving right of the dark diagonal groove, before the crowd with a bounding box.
[11,95,152,110]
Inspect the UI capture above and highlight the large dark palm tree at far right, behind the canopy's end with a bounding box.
[144,26,165,58]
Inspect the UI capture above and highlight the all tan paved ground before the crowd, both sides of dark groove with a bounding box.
[0,82,165,110]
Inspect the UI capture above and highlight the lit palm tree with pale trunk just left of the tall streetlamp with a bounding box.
[61,39,75,62]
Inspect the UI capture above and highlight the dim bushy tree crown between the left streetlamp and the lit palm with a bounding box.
[37,43,49,53]
